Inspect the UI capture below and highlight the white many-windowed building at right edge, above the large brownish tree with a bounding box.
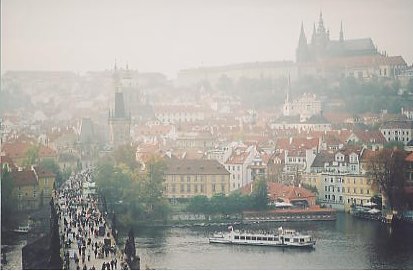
[380,120,413,145]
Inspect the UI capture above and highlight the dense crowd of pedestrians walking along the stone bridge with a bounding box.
[55,169,127,270]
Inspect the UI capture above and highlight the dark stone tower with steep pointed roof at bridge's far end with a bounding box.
[108,63,131,147]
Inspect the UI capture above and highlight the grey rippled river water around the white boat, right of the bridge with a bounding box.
[130,213,413,269]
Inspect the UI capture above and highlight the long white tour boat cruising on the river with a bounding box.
[209,226,315,248]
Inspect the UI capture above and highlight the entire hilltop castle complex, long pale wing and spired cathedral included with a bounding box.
[176,13,407,86]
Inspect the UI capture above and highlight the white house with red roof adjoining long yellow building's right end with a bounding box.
[224,146,256,191]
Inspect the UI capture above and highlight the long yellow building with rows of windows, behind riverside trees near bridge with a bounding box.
[165,159,230,199]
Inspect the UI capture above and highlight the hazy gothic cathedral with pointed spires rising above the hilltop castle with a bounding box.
[296,12,380,63]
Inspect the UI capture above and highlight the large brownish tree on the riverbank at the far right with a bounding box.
[367,148,406,210]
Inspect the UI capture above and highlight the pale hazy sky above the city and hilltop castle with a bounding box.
[1,0,413,78]
